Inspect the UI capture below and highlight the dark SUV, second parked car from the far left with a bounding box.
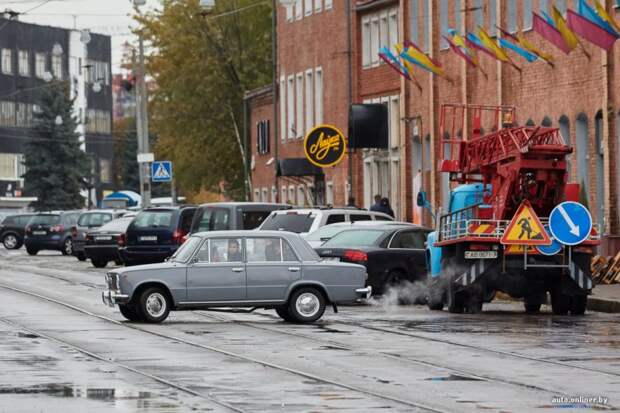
[24,211,82,255]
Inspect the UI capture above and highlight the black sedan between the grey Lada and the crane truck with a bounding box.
[316,224,431,301]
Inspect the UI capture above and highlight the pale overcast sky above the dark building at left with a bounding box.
[0,0,159,72]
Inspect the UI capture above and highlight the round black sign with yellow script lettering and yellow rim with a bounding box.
[304,125,346,168]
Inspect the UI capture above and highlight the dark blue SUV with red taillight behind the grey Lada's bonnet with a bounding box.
[120,206,196,265]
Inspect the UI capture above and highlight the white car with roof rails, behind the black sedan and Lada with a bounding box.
[259,208,393,235]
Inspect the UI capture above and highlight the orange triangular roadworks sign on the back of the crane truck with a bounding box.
[500,200,551,245]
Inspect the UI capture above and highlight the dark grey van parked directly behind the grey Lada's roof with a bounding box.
[190,202,292,234]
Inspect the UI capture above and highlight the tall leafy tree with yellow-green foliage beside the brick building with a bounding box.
[137,0,271,199]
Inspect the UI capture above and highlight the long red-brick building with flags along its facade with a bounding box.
[251,0,620,250]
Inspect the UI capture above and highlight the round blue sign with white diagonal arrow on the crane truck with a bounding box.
[549,201,592,245]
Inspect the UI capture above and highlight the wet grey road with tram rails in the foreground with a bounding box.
[0,249,620,413]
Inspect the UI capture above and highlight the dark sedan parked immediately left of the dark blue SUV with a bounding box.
[84,212,136,268]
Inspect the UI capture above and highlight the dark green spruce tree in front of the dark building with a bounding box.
[23,80,90,211]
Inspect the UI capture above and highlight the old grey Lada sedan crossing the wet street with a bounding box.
[102,231,372,323]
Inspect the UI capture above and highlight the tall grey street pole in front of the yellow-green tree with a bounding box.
[136,34,151,208]
